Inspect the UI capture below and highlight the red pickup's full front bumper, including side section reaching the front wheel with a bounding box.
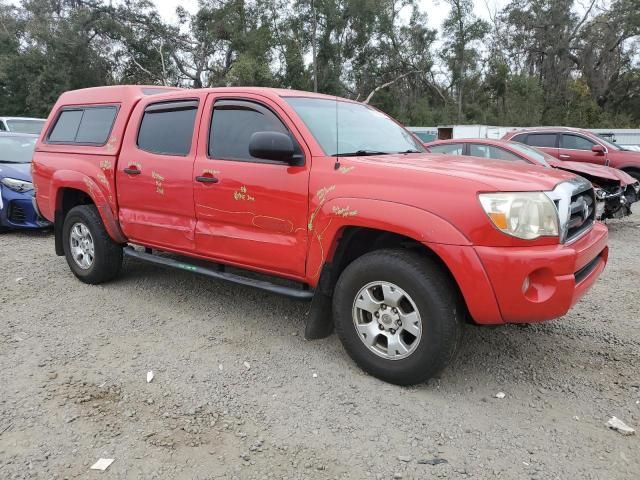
[426,223,609,325]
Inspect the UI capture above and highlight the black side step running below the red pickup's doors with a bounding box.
[123,247,313,300]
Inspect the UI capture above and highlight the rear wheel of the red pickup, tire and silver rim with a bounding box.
[62,205,122,285]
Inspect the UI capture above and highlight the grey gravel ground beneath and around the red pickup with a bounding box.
[0,214,640,480]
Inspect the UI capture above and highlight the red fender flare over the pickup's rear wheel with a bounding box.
[50,170,127,243]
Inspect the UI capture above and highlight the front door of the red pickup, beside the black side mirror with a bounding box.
[194,94,311,279]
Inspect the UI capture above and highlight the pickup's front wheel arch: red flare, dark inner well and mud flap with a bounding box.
[305,198,470,339]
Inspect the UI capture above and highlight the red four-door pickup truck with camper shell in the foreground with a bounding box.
[33,86,608,384]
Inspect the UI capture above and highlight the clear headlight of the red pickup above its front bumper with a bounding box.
[479,192,559,240]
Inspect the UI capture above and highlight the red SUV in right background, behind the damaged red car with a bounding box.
[502,127,640,180]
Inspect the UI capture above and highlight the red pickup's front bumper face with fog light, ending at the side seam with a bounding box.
[475,223,609,323]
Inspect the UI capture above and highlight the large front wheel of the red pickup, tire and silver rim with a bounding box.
[333,250,464,385]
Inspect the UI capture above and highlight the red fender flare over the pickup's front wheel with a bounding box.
[306,197,471,285]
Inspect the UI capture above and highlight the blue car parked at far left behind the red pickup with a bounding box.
[0,133,51,231]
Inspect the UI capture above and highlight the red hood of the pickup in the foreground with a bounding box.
[354,153,575,192]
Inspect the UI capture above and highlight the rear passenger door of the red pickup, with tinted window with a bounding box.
[116,95,200,251]
